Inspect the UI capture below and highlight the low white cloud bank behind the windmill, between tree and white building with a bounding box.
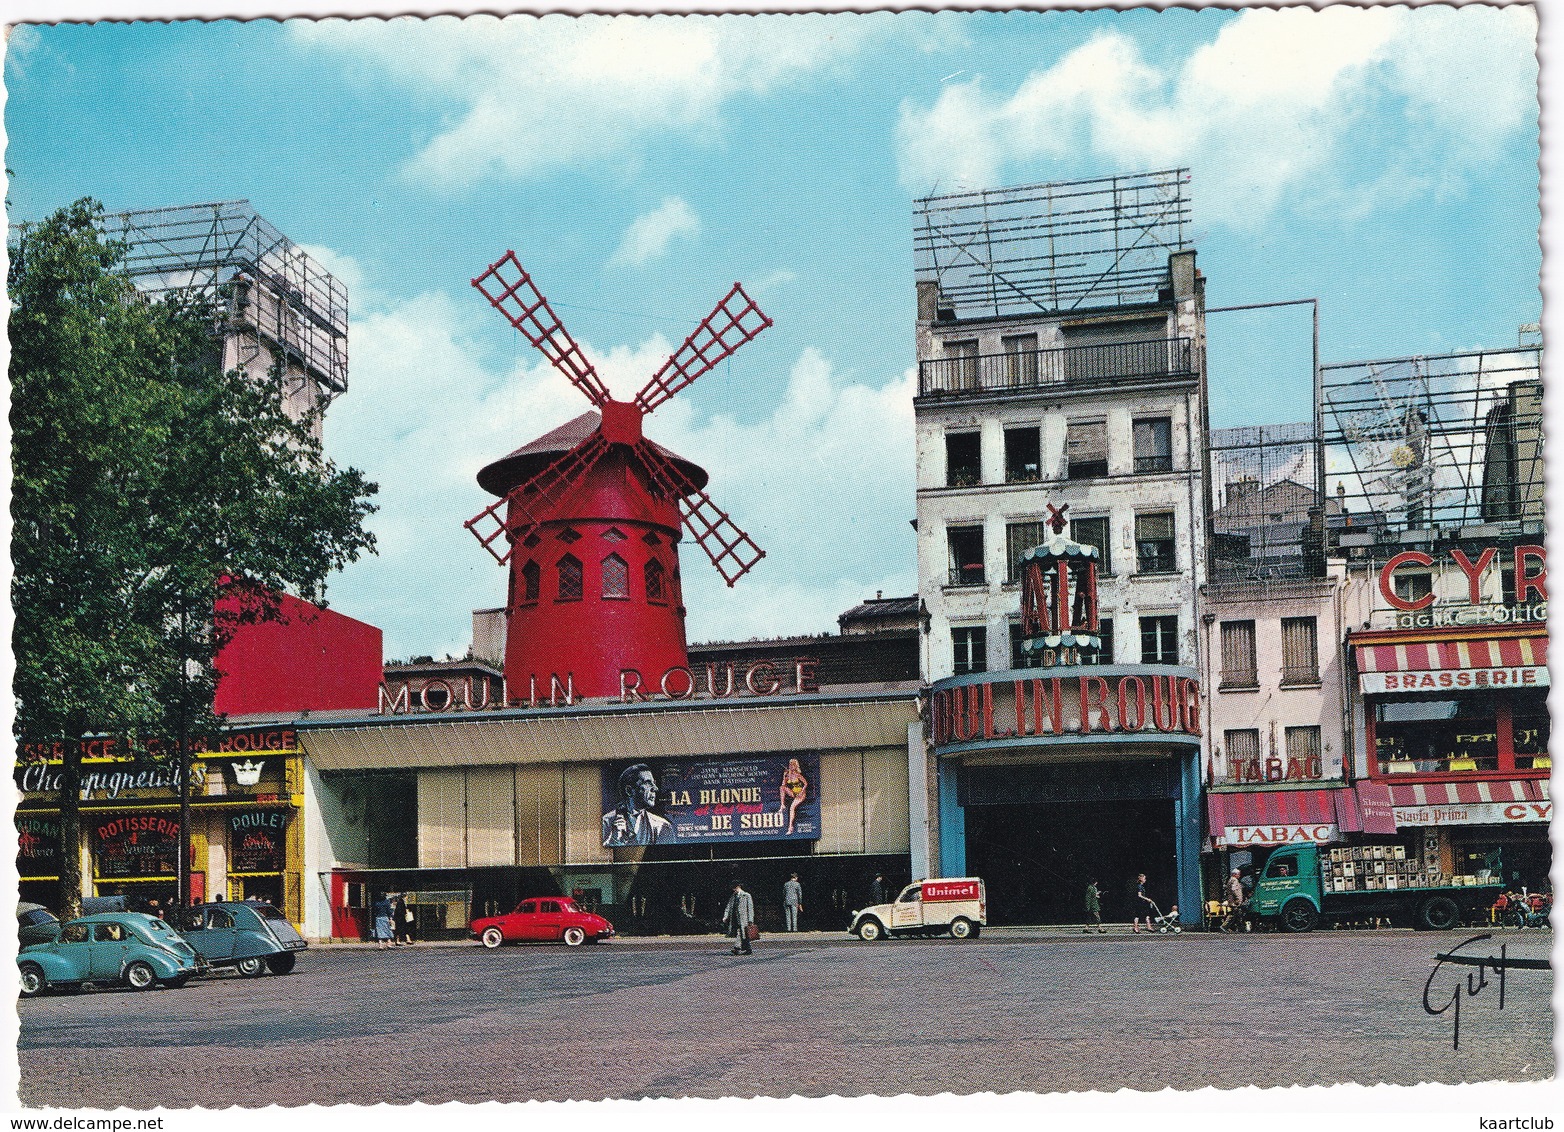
[311,249,917,657]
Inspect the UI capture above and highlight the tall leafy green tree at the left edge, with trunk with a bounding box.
[8,200,375,913]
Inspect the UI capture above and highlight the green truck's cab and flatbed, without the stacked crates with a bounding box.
[1250,844,1505,932]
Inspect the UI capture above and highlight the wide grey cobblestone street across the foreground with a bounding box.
[19,932,1553,1109]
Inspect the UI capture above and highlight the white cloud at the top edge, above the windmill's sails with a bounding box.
[286,13,898,189]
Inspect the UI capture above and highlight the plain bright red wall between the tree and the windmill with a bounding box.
[214,594,382,716]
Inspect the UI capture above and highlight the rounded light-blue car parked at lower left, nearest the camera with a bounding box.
[16,912,205,998]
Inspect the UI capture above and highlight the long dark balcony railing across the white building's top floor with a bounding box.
[918,338,1195,397]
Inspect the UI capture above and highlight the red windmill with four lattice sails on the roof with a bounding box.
[466,252,771,700]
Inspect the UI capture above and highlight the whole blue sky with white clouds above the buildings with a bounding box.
[5,8,1541,657]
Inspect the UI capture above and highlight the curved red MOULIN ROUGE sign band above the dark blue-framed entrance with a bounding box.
[929,672,1201,747]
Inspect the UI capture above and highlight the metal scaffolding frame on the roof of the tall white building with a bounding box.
[913,169,1190,319]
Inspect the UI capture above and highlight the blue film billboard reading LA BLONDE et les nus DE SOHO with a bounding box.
[602,754,820,849]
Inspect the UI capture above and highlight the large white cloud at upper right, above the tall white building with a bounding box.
[898,6,1536,225]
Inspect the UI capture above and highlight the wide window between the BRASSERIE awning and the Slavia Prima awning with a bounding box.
[1375,693,1498,774]
